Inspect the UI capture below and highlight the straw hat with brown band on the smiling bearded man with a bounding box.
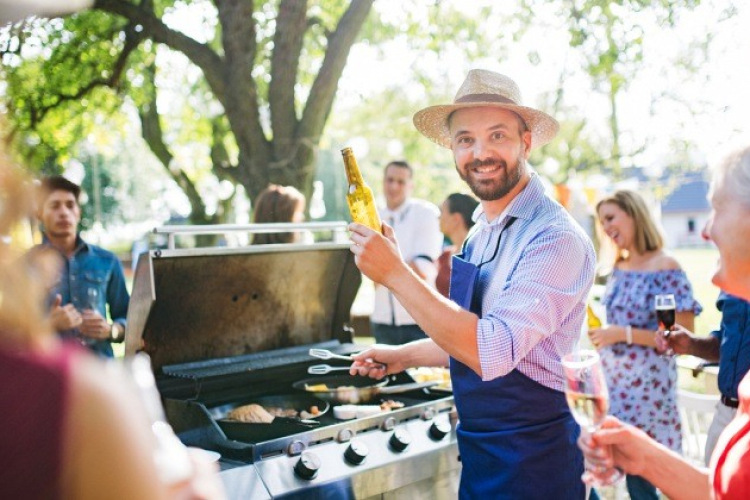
[414,69,560,148]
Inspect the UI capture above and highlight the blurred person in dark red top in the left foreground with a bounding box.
[0,152,223,499]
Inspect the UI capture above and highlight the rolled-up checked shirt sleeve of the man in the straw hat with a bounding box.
[477,230,595,380]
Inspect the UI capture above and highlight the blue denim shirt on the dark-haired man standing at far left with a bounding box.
[32,235,130,357]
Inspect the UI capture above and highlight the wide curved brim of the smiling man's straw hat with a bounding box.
[413,102,560,149]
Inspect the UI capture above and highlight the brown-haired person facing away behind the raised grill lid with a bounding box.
[253,184,306,245]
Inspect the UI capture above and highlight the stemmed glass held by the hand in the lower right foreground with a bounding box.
[562,350,623,487]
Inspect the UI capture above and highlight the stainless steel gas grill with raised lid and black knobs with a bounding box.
[125,223,460,499]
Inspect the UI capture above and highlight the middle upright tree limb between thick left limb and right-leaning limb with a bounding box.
[268,0,308,152]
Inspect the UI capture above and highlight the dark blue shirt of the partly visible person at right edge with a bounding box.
[711,292,750,399]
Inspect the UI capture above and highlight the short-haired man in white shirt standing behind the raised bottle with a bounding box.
[370,161,443,344]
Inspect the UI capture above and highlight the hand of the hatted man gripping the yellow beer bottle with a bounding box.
[349,222,408,286]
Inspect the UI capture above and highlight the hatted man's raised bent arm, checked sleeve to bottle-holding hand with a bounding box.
[349,224,594,380]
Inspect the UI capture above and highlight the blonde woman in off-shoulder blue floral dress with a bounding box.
[589,191,702,500]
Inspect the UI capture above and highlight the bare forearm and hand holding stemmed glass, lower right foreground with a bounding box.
[578,416,711,500]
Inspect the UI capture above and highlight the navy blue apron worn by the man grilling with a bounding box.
[450,218,586,500]
